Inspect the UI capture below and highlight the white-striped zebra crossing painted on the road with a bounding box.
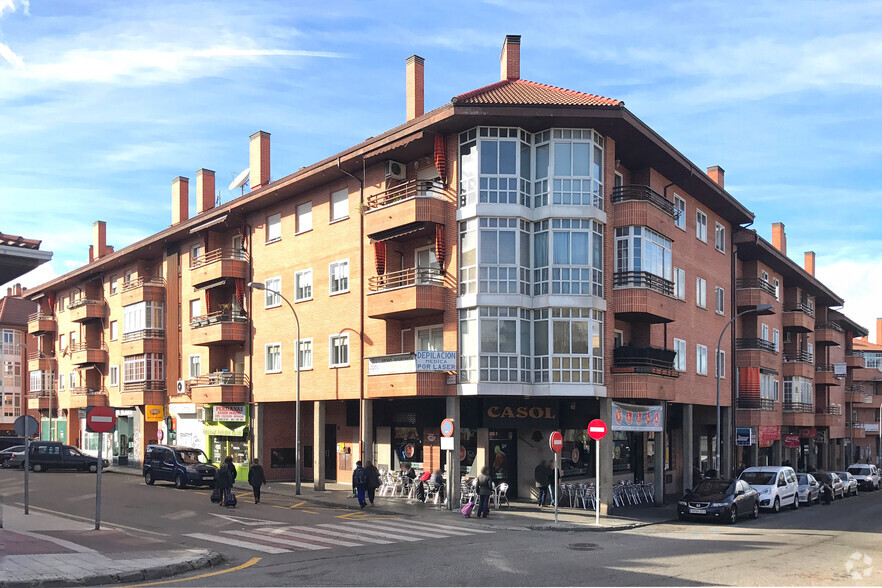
[185,519,495,554]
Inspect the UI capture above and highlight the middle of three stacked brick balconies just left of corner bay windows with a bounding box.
[366,268,451,320]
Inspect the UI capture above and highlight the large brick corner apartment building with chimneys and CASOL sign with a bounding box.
[22,36,872,500]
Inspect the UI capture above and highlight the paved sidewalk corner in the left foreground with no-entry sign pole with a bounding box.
[0,504,222,588]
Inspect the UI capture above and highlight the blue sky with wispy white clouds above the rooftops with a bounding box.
[0,0,882,340]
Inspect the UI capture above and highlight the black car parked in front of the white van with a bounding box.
[677,480,759,524]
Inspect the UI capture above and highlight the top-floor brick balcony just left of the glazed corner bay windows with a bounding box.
[364,180,453,235]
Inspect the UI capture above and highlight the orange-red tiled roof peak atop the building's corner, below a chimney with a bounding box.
[452,80,625,107]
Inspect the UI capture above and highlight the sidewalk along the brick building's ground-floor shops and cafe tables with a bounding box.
[108,469,677,531]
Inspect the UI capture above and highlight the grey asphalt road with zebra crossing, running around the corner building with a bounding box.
[0,470,882,587]
